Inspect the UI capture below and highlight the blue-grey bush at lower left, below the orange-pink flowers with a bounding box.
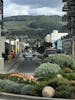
[0,79,24,94]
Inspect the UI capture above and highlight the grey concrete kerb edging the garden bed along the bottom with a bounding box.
[0,92,75,100]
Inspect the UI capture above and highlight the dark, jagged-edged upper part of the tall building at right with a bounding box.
[62,0,75,34]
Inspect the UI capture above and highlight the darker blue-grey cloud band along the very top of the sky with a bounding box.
[11,0,62,7]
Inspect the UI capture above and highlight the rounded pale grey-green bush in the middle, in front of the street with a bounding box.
[35,62,61,77]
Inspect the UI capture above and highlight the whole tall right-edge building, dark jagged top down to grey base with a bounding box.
[62,0,75,58]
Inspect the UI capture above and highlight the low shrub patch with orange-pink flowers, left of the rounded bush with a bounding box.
[8,73,37,84]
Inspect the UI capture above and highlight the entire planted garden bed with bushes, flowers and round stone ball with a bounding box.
[0,55,75,100]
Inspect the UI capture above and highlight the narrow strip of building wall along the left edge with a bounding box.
[0,0,5,73]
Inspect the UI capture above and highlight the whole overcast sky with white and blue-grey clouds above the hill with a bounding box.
[4,0,63,17]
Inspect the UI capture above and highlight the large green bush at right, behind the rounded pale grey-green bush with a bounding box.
[43,54,75,69]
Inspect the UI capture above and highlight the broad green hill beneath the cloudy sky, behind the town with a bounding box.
[4,16,63,38]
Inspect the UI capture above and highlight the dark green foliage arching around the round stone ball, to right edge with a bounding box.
[35,78,75,99]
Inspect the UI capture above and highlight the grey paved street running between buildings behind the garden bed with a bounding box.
[6,54,41,73]
